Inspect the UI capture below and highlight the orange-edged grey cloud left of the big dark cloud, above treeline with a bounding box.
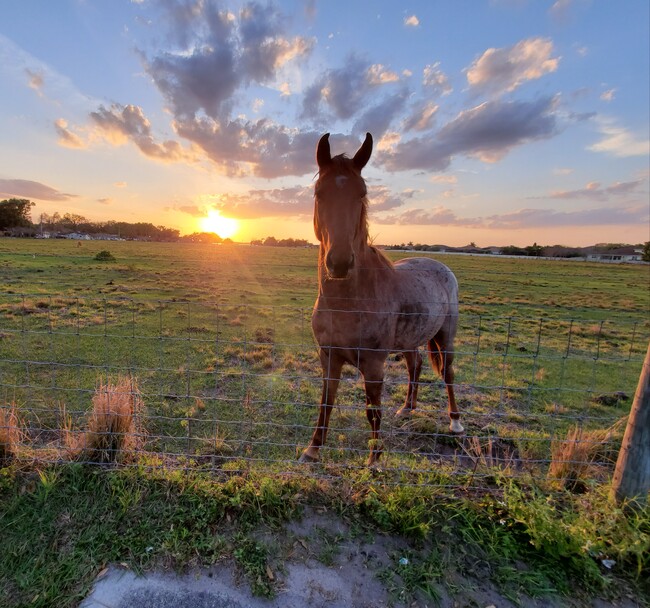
[90,104,193,162]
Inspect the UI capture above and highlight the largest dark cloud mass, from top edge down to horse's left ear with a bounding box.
[136,0,317,178]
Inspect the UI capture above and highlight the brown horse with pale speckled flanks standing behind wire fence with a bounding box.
[300,133,463,465]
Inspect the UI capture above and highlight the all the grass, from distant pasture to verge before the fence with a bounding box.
[0,239,650,608]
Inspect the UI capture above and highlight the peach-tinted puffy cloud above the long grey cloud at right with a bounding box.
[466,38,560,95]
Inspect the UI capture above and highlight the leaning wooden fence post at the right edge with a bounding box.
[612,344,650,507]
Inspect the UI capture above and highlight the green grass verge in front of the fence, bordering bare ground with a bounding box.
[0,461,650,608]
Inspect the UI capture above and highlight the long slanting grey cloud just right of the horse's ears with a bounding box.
[377,97,557,171]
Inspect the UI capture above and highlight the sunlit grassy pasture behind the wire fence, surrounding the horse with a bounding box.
[0,239,650,485]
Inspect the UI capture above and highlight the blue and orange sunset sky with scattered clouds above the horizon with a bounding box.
[0,0,650,246]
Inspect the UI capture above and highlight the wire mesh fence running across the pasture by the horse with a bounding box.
[0,293,650,485]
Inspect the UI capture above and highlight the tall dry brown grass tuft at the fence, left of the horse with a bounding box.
[73,377,144,463]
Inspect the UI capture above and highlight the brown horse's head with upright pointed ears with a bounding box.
[314,133,372,279]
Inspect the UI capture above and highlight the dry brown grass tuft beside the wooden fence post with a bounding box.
[548,418,625,490]
